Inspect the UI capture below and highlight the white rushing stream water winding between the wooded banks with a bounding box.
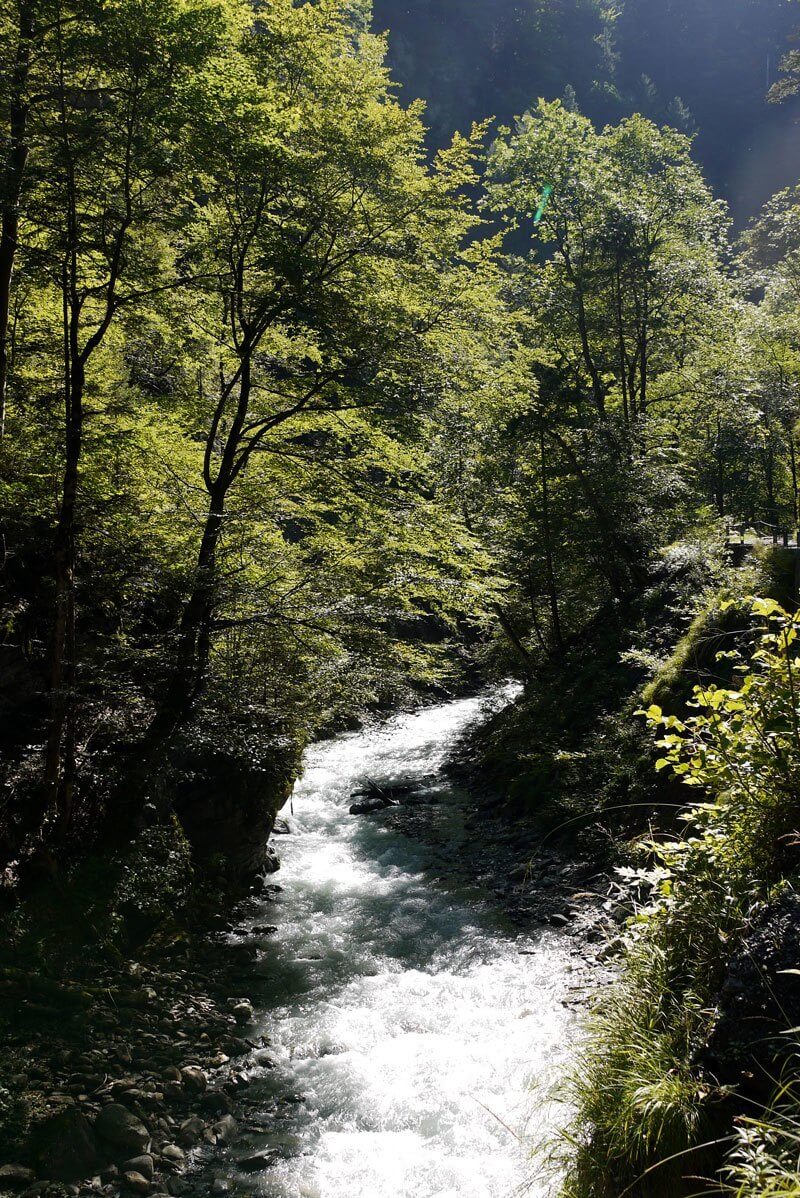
[221,698,571,1198]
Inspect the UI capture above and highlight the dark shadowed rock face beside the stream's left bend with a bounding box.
[167,749,297,889]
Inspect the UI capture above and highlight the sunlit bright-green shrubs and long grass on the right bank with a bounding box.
[565,599,800,1196]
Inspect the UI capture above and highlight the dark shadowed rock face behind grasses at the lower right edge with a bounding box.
[703,894,800,1093]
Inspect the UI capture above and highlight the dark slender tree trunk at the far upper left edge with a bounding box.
[0,0,35,438]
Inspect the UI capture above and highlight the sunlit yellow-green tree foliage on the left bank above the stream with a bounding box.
[0,0,501,857]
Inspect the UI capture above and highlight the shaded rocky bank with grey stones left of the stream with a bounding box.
[0,885,287,1198]
